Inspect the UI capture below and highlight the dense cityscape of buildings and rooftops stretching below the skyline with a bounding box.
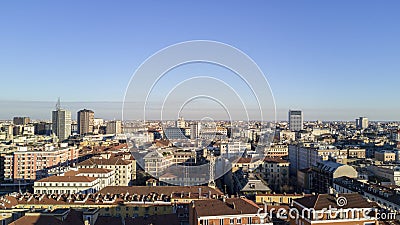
[0,100,400,225]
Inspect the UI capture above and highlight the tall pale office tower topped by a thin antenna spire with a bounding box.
[51,99,71,141]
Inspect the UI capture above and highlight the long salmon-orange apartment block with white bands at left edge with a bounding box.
[4,143,79,181]
